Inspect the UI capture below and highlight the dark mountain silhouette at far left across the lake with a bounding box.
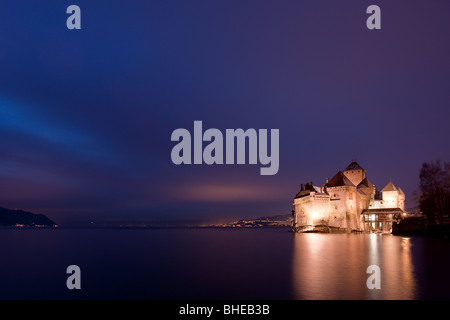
[0,207,57,227]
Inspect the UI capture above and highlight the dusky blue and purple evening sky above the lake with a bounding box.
[0,0,450,225]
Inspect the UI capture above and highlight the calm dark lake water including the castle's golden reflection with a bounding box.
[0,228,450,300]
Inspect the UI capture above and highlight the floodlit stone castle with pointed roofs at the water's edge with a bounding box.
[293,161,405,232]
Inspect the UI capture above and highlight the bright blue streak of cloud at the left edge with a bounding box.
[0,97,123,166]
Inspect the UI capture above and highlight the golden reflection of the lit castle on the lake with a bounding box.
[292,233,416,300]
